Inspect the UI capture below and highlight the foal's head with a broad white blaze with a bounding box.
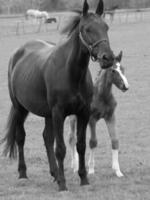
[110,51,129,92]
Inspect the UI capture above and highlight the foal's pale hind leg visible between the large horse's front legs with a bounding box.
[69,115,79,172]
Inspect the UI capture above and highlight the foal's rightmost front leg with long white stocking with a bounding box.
[105,114,123,177]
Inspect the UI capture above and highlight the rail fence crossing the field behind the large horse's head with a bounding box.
[0,8,150,37]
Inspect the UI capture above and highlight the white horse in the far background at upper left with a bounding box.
[25,9,49,20]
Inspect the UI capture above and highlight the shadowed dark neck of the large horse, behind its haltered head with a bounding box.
[67,34,90,85]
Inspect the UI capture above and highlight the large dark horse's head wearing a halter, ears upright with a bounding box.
[79,0,114,69]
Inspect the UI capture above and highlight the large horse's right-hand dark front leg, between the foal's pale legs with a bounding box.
[77,111,89,185]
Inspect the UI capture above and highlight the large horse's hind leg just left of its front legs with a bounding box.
[43,117,58,180]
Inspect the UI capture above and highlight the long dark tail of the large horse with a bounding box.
[0,105,19,158]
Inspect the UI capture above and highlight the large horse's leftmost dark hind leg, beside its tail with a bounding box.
[16,107,28,178]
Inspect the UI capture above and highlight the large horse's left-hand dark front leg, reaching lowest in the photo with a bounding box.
[52,106,67,191]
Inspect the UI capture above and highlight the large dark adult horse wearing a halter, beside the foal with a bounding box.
[1,0,114,191]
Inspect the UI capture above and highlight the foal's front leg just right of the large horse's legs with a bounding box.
[88,117,97,174]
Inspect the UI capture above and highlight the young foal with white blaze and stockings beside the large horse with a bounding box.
[69,52,129,177]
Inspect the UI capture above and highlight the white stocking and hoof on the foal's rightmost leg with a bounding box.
[112,150,124,177]
